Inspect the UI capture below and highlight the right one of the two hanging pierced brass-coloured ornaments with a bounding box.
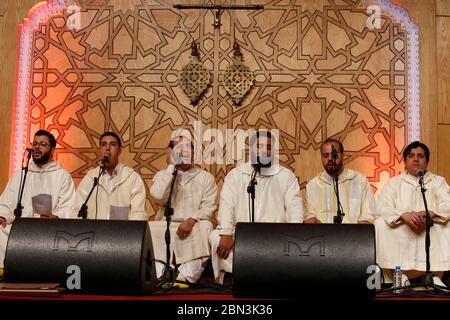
[222,43,254,105]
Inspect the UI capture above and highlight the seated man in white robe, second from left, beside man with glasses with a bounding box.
[74,132,148,220]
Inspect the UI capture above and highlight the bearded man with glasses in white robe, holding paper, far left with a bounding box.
[0,130,75,268]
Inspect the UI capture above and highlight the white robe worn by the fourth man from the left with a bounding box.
[210,163,303,283]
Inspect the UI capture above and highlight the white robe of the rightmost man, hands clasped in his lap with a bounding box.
[375,172,450,271]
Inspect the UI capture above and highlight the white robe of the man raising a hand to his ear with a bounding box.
[149,165,217,264]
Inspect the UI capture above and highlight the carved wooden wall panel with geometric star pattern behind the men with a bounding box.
[12,0,418,216]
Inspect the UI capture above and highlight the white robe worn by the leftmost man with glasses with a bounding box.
[0,161,75,268]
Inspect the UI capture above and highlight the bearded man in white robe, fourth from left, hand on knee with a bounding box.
[210,131,303,284]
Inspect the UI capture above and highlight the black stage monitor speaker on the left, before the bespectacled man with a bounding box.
[4,218,157,294]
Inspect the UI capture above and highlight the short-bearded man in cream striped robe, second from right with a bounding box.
[305,139,375,223]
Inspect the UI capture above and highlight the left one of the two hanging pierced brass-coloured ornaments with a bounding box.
[180,41,211,105]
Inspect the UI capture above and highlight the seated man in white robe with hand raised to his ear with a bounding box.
[149,136,217,287]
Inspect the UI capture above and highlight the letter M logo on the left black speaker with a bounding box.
[53,231,95,252]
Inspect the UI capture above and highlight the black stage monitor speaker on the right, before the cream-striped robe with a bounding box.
[233,223,379,299]
